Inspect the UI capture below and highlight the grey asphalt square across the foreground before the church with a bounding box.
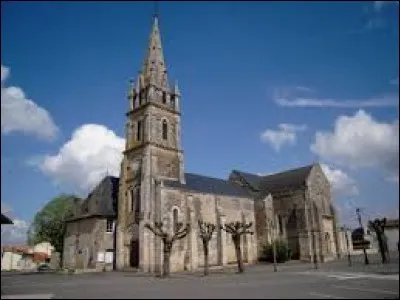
[1,255,399,299]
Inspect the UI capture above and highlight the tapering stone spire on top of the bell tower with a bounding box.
[142,11,169,89]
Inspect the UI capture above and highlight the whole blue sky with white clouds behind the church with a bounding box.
[1,1,399,244]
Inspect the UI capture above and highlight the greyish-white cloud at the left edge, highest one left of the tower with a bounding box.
[1,65,58,139]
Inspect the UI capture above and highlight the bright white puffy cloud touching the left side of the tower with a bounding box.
[30,124,125,192]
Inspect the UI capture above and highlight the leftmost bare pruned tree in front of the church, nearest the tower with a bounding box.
[145,222,190,277]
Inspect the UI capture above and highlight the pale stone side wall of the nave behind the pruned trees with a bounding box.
[149,187,257,272]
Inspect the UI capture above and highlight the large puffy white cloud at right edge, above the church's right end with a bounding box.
[310,110,399,182]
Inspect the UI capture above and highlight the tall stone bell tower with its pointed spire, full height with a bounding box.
[116,14,185,271]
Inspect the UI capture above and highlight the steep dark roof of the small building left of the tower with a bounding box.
[68,176,119,221]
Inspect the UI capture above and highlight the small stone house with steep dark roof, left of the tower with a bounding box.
[63,176,119,270]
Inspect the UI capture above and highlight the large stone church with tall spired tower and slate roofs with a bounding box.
[64,16,340,272]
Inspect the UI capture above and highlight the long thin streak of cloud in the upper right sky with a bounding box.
[274,95,399,108]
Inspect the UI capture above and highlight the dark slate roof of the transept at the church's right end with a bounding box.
[233,165,314,193]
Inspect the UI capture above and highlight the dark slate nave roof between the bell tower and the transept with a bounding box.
[164,173,249,198]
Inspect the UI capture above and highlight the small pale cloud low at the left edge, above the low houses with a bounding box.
[1,203,29,244]
